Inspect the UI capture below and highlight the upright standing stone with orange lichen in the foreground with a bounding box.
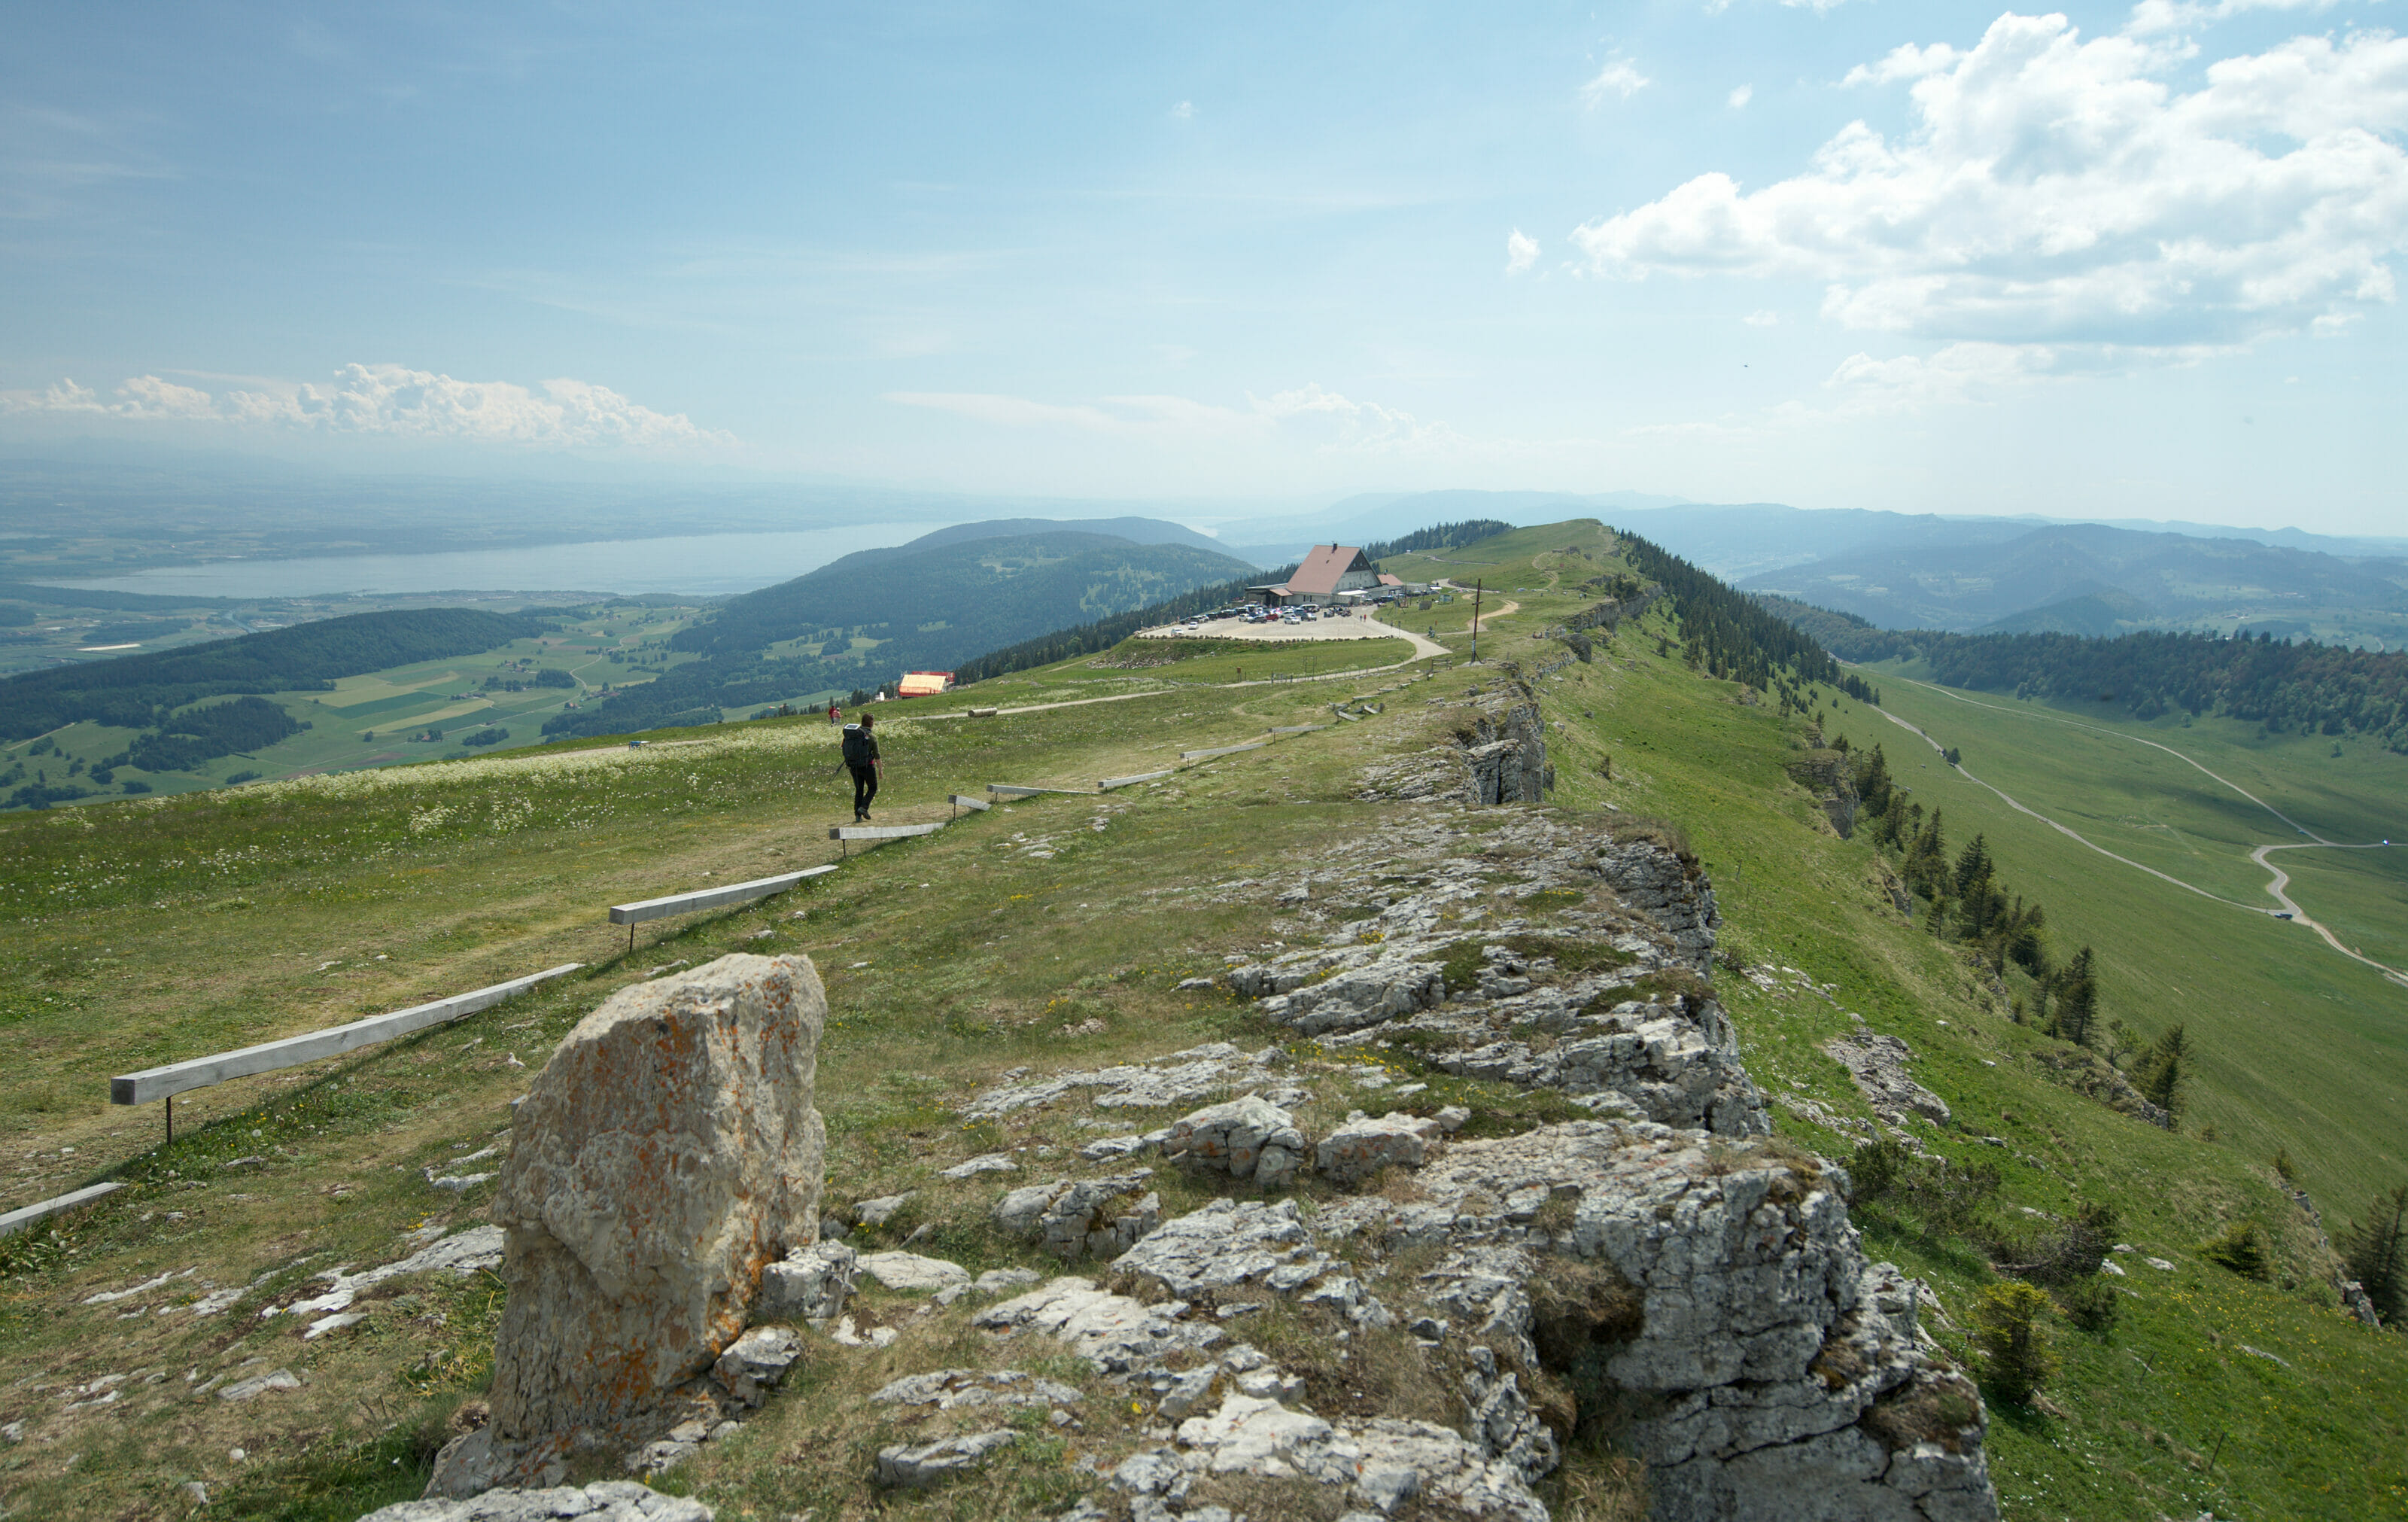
[431,956,826,1496]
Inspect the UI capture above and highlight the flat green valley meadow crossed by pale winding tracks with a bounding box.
[1832,677,2408,1216]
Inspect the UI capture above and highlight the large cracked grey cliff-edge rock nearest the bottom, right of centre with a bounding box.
[1319,1122,1996,1522]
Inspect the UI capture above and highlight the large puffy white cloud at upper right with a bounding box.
[1573,14,2408,354]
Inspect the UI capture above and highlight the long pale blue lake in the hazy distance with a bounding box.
[53,522,944,600]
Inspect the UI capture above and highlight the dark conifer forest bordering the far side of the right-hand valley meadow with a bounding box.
[1758,597,2408,753]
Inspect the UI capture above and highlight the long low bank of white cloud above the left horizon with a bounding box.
[0,364,734,448]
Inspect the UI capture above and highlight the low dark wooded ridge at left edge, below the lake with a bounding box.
[0,607,549,753]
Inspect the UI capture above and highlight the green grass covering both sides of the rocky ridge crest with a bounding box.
[0,525,2408,1520]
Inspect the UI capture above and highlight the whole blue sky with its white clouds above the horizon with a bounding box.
[0,0,2408,534]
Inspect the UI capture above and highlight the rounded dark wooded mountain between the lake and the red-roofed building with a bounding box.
[544,530,1257,735]
